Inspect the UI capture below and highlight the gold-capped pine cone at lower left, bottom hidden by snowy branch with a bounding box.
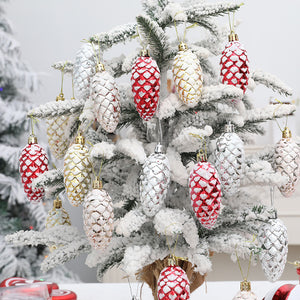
[45,198,71,229]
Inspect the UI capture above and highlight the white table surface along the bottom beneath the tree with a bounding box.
[59,281,298,300]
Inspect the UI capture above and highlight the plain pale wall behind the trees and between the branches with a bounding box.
[6,0,300,282]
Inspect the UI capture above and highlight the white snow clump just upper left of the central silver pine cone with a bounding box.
[116,138,146,164]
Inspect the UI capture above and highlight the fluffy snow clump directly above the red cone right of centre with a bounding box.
[171,125,213,153]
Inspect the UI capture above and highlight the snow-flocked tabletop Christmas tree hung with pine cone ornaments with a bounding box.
[7,0,299,299]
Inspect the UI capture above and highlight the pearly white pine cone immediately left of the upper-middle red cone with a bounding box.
[91,64,121,132]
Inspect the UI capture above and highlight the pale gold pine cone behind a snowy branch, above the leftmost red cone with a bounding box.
[46,93,69,159]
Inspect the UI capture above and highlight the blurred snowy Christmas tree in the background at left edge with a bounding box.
[0,0,77,281]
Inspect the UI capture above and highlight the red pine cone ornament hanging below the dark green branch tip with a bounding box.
[131,50,160,121]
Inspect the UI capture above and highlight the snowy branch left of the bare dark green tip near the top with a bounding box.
[90,23,137,50]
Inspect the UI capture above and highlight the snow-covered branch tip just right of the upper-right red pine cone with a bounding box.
[251,70,293,96]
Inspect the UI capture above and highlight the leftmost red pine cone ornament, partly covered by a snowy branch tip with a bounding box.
[19,135,48,202]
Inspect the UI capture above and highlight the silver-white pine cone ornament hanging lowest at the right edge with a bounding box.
[258,219,288,281]
